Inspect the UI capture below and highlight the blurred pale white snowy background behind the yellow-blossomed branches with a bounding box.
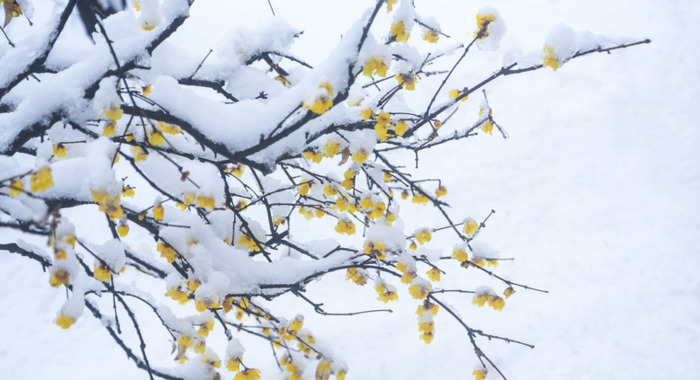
[0,0,700,380]
